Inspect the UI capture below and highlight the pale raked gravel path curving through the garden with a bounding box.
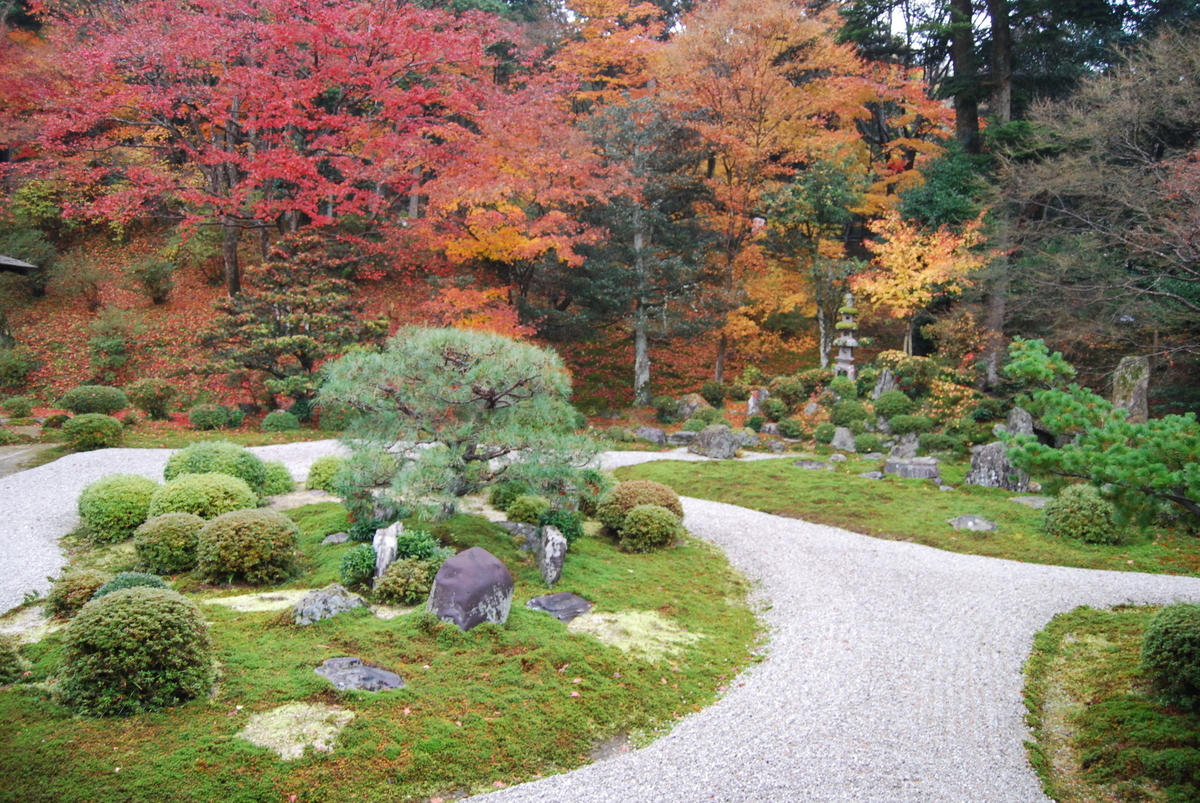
[0,442,1200,803]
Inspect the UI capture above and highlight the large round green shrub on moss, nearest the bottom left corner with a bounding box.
[58,588,212,717]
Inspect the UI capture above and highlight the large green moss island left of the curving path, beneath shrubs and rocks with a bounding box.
[0,503,757,803]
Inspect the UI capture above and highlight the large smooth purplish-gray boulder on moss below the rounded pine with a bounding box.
[426,546,512,631]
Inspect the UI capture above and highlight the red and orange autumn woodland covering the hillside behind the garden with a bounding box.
[0,0,1200,414]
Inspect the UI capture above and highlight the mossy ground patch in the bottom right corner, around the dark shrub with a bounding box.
[1025,607,1200,803]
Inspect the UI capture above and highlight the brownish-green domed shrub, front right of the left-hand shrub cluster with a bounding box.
[196,506,300,583]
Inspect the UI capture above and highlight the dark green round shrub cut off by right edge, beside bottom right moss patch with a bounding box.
[1141,603,1200,713]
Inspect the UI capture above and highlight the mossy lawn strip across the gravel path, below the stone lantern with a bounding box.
[617,460,1200,575]
